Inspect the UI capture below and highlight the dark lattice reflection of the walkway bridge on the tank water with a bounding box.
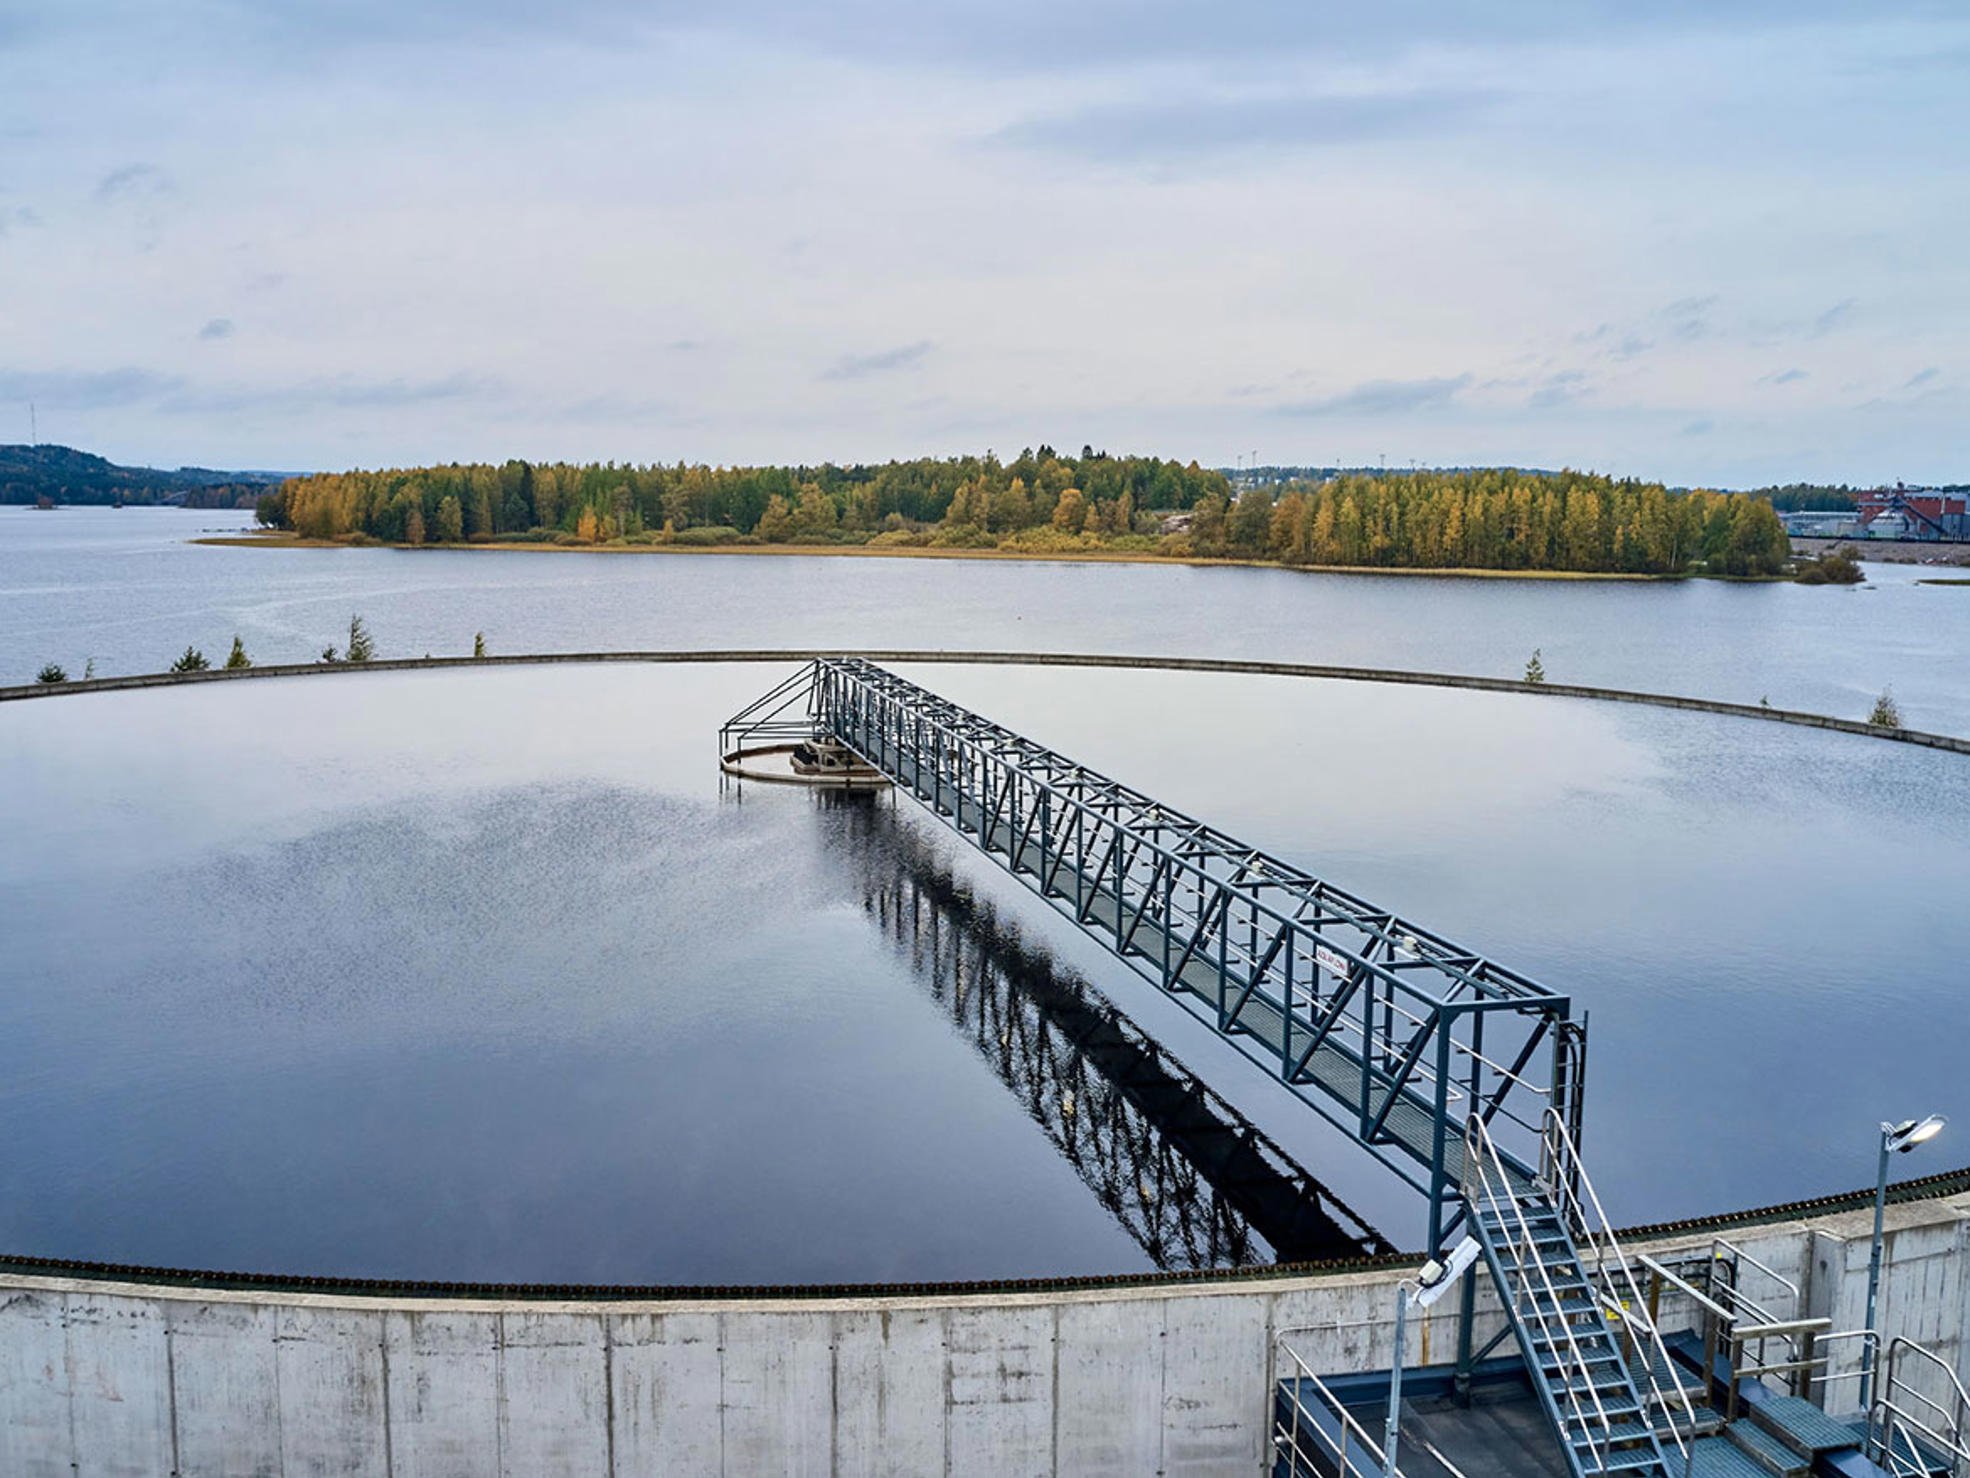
[843,798,1395,1269]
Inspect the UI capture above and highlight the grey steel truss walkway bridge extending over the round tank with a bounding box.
[719,658,1586,1251]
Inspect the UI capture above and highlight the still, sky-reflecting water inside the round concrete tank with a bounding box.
[0,658,1970,1283]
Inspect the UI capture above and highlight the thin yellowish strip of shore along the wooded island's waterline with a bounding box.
[189,532,1741,583]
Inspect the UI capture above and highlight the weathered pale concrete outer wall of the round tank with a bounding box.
[0,1196,1970,1478]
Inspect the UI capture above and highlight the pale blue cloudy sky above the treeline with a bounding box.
[0,0,1970,487]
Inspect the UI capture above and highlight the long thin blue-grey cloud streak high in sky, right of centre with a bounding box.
[991,91,1493,164]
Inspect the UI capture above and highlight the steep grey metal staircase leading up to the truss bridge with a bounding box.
[1464,1115,1698,1478]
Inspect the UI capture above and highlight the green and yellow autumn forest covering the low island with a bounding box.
[260,447,1791,575]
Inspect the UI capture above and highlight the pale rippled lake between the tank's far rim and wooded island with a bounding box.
[11,508,1970,735]
